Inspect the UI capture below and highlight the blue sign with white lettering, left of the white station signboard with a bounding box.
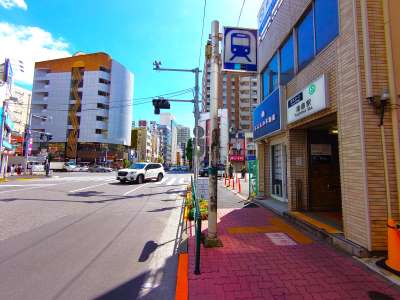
[253,89,281,139]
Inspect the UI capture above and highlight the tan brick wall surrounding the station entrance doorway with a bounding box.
[258,0,398,250]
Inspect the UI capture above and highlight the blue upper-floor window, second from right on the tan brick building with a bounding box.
[297,9,315,70]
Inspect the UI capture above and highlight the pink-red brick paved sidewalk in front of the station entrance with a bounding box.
[189,208,400,300]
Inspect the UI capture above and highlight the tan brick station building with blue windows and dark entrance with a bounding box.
[253,0,400,255]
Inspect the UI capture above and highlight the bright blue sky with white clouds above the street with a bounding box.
[0,0,262,128]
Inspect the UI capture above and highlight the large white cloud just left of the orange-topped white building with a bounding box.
[0,21,71,84]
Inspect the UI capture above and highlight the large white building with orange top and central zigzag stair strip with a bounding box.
[32,52,133,162]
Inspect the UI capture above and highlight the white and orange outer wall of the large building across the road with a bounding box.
[32,53,133,151]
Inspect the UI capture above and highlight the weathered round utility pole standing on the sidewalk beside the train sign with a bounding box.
[206,21,220,247]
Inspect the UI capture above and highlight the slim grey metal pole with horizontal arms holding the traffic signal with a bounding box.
[153,65,201,183]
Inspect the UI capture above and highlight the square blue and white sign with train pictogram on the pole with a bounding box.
[224,27,257,72]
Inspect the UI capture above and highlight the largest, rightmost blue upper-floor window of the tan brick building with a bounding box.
[314,0,339,53]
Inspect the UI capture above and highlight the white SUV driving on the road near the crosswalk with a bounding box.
[117,162,165,183]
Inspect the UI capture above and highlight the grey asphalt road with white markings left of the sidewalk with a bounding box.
[0,173,190,300]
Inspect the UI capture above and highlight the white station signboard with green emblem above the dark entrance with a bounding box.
[287,75,329,124]
